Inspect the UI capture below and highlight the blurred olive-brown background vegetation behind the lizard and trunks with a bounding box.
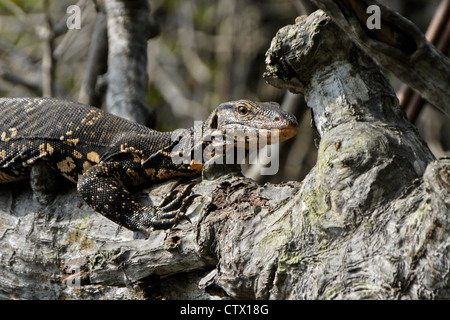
[0,0,450,182]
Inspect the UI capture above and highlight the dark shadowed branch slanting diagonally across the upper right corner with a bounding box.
[313,0,450,116]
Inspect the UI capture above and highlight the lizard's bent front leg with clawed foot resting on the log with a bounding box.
[77,162,193,235]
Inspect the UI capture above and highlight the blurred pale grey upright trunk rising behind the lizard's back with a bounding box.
[104,0,159,126]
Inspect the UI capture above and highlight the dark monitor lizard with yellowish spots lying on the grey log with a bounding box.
[0,98,298,234]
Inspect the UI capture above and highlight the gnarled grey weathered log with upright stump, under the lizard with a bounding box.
[0,11,450,299]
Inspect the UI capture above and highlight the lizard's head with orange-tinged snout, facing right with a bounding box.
[205,100,298,144]
